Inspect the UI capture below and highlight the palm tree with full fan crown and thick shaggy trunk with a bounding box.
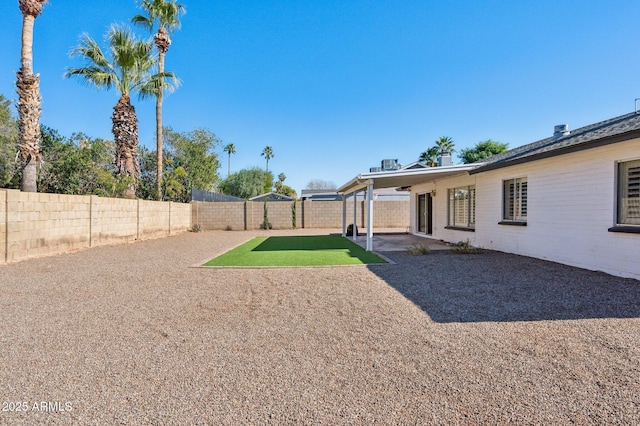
[65,26,175,198]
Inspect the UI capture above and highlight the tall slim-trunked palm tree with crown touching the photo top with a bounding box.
[131,0,185,199]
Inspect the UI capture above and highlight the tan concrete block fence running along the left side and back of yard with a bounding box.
[0,189,410,264]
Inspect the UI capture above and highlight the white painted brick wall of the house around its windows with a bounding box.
[411,139,640,279]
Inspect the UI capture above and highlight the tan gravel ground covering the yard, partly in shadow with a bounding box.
[0,231,640,425]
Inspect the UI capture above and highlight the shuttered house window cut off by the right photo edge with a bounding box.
[617,160,640,225]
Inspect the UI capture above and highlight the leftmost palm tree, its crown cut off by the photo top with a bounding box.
[16,0,47,192]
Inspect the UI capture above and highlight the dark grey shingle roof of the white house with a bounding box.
[469,112,640,174]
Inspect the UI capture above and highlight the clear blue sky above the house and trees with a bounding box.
[0,0,640,192]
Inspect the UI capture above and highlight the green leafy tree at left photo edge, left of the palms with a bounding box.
[0,95,22,189]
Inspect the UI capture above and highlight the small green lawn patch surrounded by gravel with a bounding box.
[204,235,387,266]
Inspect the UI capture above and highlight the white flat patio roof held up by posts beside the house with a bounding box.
[337,163,484,194]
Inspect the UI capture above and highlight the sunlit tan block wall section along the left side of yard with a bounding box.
[0,189,191,263]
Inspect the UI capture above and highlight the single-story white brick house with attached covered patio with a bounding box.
[338,112,640,279]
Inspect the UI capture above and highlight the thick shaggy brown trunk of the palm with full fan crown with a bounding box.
[111,94,140,198]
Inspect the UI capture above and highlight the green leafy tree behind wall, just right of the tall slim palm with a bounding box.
[164,127,221,202]
